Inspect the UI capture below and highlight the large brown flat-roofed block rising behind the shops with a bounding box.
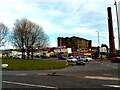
[57,36,92,51]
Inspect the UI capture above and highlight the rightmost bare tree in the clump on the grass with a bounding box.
[30,26,49,59]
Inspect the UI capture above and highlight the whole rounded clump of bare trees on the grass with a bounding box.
[12,19,49,59]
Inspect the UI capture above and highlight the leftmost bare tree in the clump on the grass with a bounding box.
[12,19,27,59]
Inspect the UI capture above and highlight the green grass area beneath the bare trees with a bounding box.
[2,58,67,70]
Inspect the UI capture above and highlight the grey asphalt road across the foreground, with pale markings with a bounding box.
[2,60,120,90]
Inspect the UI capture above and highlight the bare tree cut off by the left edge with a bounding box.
[0,23,9,47]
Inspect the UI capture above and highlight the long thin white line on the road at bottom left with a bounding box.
[3,81,58,89]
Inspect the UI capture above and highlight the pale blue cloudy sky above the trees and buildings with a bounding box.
[0,0,120,49]
